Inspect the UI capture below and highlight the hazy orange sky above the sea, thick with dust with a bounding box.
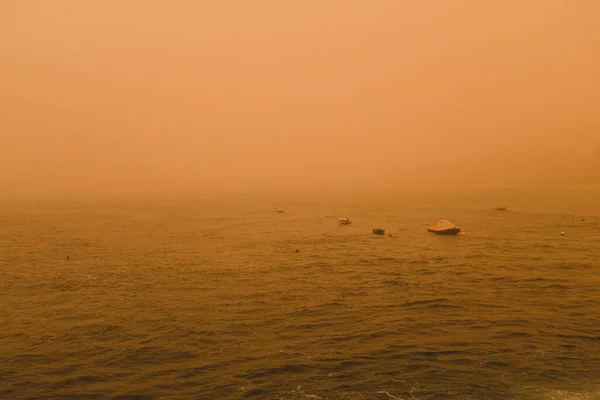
[0,0,600,194]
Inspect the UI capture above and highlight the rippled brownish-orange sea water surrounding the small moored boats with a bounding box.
[0,187,600,400]
